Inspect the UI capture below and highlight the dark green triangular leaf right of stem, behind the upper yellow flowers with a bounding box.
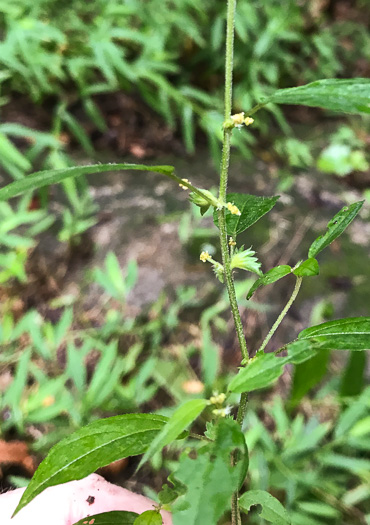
[213,193,279,238]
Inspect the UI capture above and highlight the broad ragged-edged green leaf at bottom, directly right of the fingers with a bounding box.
[172,419,247,525]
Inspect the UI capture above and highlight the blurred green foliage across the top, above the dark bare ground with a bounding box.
[0,0,370,161]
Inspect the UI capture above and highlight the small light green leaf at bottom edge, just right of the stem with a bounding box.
[239,490,291,525]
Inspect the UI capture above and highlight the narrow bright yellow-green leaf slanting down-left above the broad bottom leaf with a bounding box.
[138,399,208,469]
